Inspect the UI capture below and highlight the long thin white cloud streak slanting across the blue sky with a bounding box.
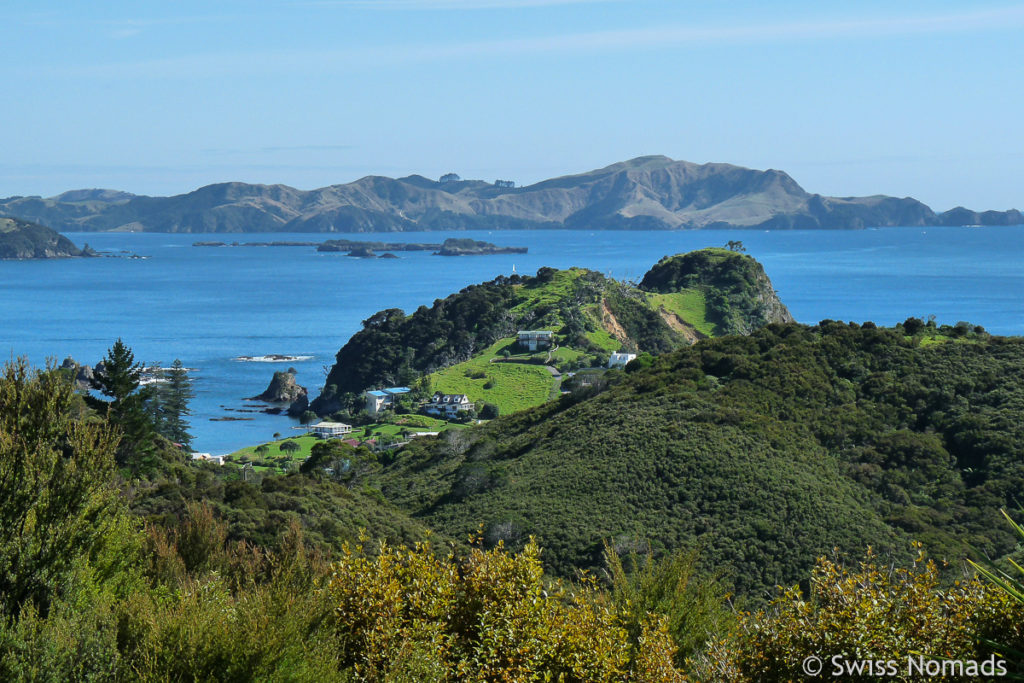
[24,5,1024,78]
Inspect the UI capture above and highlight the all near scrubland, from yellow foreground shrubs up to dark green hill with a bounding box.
[6,327,1024,683]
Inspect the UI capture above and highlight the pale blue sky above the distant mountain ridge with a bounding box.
[0,0,1024,210]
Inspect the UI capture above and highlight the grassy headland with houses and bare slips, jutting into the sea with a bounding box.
[311,249,792,415]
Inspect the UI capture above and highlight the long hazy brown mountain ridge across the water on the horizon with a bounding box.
[0,156,1024,232]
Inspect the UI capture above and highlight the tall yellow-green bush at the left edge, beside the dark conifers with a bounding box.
[0,359,129,614]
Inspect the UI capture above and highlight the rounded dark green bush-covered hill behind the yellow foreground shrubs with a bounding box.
[372,322,1024,591]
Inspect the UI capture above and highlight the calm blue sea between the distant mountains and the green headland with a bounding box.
[0,226,1024,454]
